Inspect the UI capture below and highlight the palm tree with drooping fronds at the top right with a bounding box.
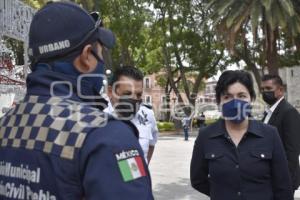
[203,0,300,74]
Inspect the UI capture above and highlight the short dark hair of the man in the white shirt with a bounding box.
[109,66,144,85]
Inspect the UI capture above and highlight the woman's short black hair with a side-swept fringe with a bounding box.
[215,70,256,104]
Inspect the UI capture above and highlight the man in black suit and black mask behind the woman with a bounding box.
[261,75,300,193]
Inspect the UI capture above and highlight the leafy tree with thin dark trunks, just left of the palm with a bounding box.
[153,0,228,109]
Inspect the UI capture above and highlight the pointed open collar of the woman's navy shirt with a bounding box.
[210,119,264,138]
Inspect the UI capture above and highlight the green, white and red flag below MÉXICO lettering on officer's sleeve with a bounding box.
[117,151,146,182]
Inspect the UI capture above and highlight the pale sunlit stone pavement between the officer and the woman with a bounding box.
[149,136,300,200]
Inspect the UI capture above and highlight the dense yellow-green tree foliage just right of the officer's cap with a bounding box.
[96,0,153,70]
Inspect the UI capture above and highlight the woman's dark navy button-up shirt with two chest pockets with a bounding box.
[190,120,293,200]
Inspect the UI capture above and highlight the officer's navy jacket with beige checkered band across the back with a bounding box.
[0,70,153,200]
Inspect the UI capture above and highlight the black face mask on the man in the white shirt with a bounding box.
[115,97,142,120]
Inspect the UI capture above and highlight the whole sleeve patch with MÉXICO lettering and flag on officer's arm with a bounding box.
[116,150,146,182]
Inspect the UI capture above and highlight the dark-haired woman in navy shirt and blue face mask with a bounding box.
[190,71,293,200]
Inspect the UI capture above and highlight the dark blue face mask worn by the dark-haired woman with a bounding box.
[222,99,251,124]
